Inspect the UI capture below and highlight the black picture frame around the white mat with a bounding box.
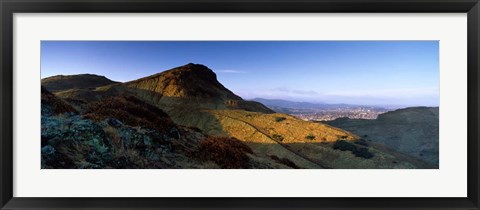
[0,0,480,209]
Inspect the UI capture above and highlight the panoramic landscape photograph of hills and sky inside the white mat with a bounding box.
[39,41,440,169]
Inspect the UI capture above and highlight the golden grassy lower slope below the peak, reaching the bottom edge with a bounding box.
[165,109,431,168]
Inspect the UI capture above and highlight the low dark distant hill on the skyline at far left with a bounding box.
[42,74,118,92]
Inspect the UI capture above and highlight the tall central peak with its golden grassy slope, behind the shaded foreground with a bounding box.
[119,64,431,168]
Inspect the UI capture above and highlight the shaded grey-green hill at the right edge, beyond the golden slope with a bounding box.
[324,107,439,165]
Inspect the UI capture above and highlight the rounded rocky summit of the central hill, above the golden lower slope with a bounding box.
[123,63,273,113]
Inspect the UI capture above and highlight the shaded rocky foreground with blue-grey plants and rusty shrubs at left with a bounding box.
[41,89,205,169]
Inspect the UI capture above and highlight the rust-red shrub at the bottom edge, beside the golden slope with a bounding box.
[194,137,253,168]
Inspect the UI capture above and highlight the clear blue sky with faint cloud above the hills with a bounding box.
[41,41,439,106]
